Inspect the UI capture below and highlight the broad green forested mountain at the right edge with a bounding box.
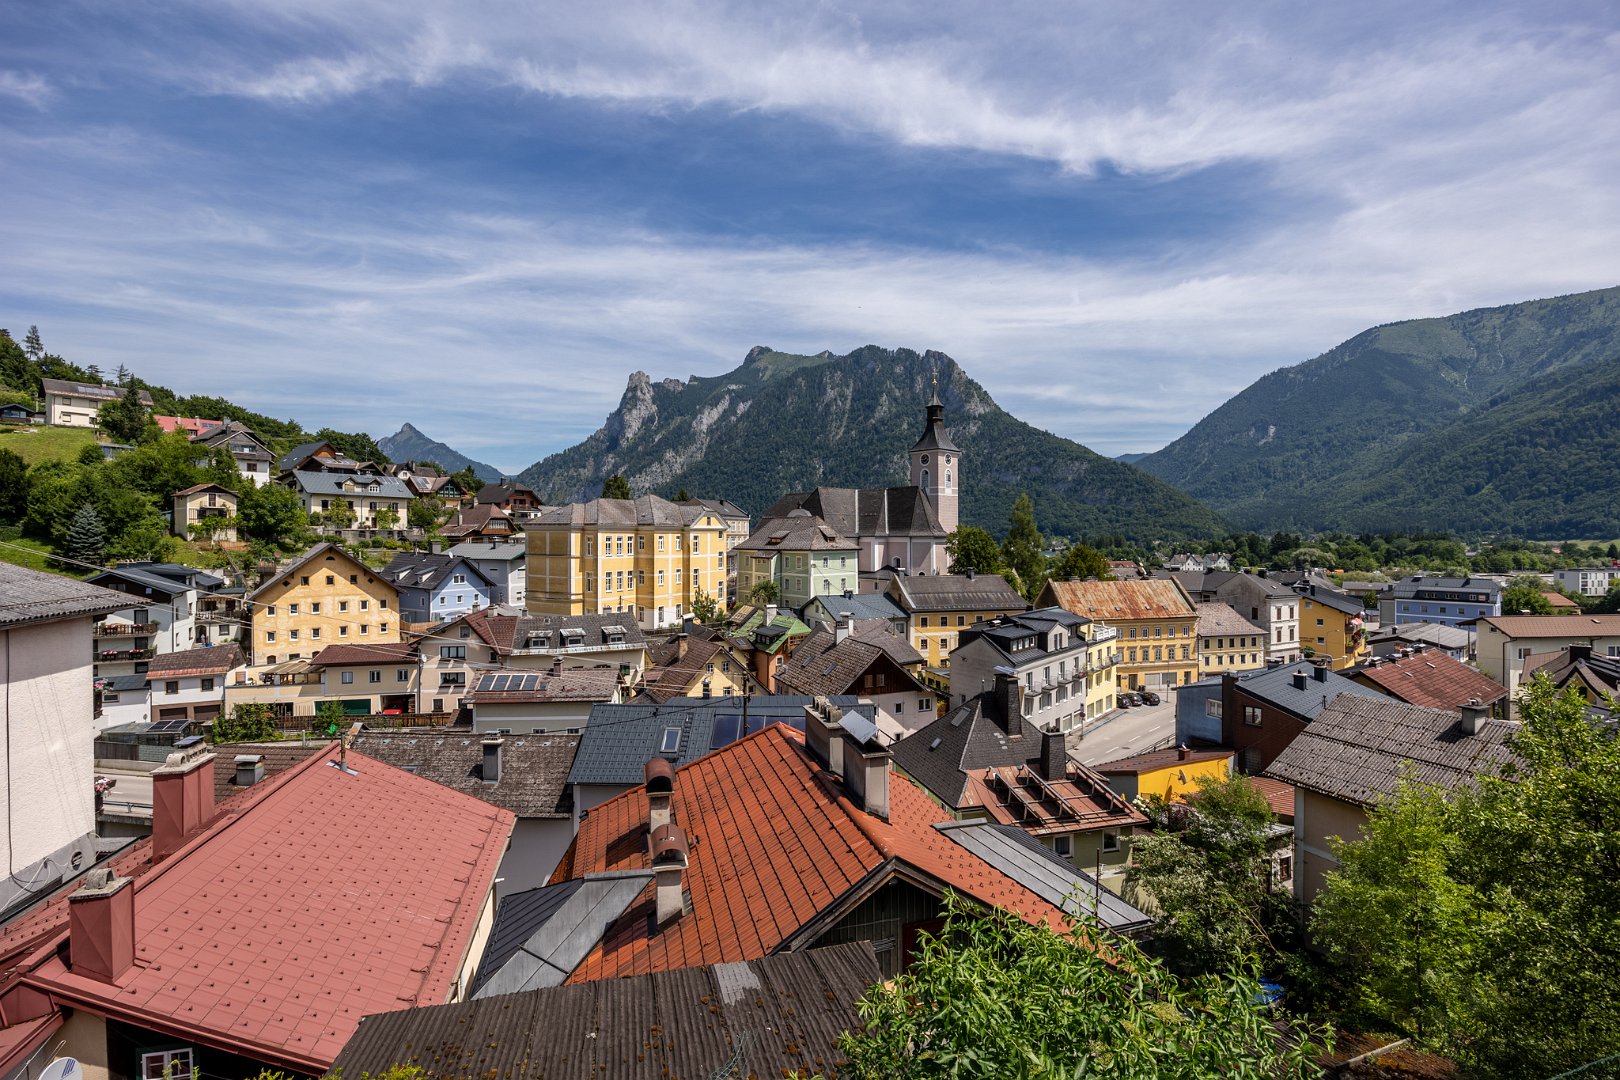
[1139,288,1620,538]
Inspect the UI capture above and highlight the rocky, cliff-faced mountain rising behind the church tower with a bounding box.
[520,345,1225,539]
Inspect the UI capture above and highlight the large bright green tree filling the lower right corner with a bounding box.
[1311,677,1620,1077]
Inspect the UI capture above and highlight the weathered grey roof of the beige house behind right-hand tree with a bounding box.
[1265,695,1518,806]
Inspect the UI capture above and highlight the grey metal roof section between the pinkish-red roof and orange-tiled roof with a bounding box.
[471,870,653,997]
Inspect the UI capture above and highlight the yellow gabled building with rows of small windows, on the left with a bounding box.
[248,544,400,665]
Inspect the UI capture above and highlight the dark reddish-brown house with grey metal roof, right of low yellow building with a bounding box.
[1218,661,1383,776]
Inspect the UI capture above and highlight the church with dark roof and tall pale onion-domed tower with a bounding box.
[761,385,962,573]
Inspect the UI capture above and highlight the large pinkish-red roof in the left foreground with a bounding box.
[11,746,515,1074]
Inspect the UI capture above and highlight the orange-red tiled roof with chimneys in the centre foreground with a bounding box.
[552,724,1063,983]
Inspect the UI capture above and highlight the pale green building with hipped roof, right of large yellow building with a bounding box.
[732,508,860,610]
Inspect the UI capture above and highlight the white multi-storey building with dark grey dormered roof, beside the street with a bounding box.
[951,607,1119,732]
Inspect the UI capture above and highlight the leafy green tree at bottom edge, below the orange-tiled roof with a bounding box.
[822,894,1328,1080]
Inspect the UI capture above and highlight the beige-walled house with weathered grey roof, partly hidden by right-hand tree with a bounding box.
[1267,695,1515,904]
